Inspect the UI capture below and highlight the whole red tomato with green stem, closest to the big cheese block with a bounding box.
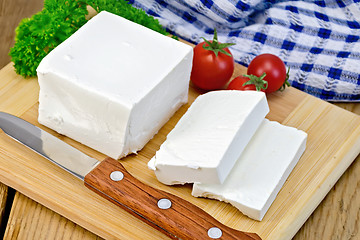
[190,32,234,90]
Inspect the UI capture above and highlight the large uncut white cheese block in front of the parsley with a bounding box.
[37,11,193,159]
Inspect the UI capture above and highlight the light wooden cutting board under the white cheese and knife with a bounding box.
[0,64,360,240]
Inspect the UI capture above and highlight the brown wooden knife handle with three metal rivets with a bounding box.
[85,158,261,240]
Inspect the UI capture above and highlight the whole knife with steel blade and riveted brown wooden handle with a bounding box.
[0,112,261,240]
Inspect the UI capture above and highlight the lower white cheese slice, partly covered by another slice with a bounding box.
[192,119,307,221]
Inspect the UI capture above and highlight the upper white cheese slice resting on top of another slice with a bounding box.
[148,90,269,185]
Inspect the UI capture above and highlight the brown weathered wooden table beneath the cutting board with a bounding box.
[0,0,360,240]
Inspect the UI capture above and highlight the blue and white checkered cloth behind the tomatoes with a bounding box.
[129,0,360,102]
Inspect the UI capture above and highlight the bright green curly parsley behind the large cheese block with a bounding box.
[9,0,168,77]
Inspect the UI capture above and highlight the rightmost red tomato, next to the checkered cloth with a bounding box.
[247,53,289,93]
